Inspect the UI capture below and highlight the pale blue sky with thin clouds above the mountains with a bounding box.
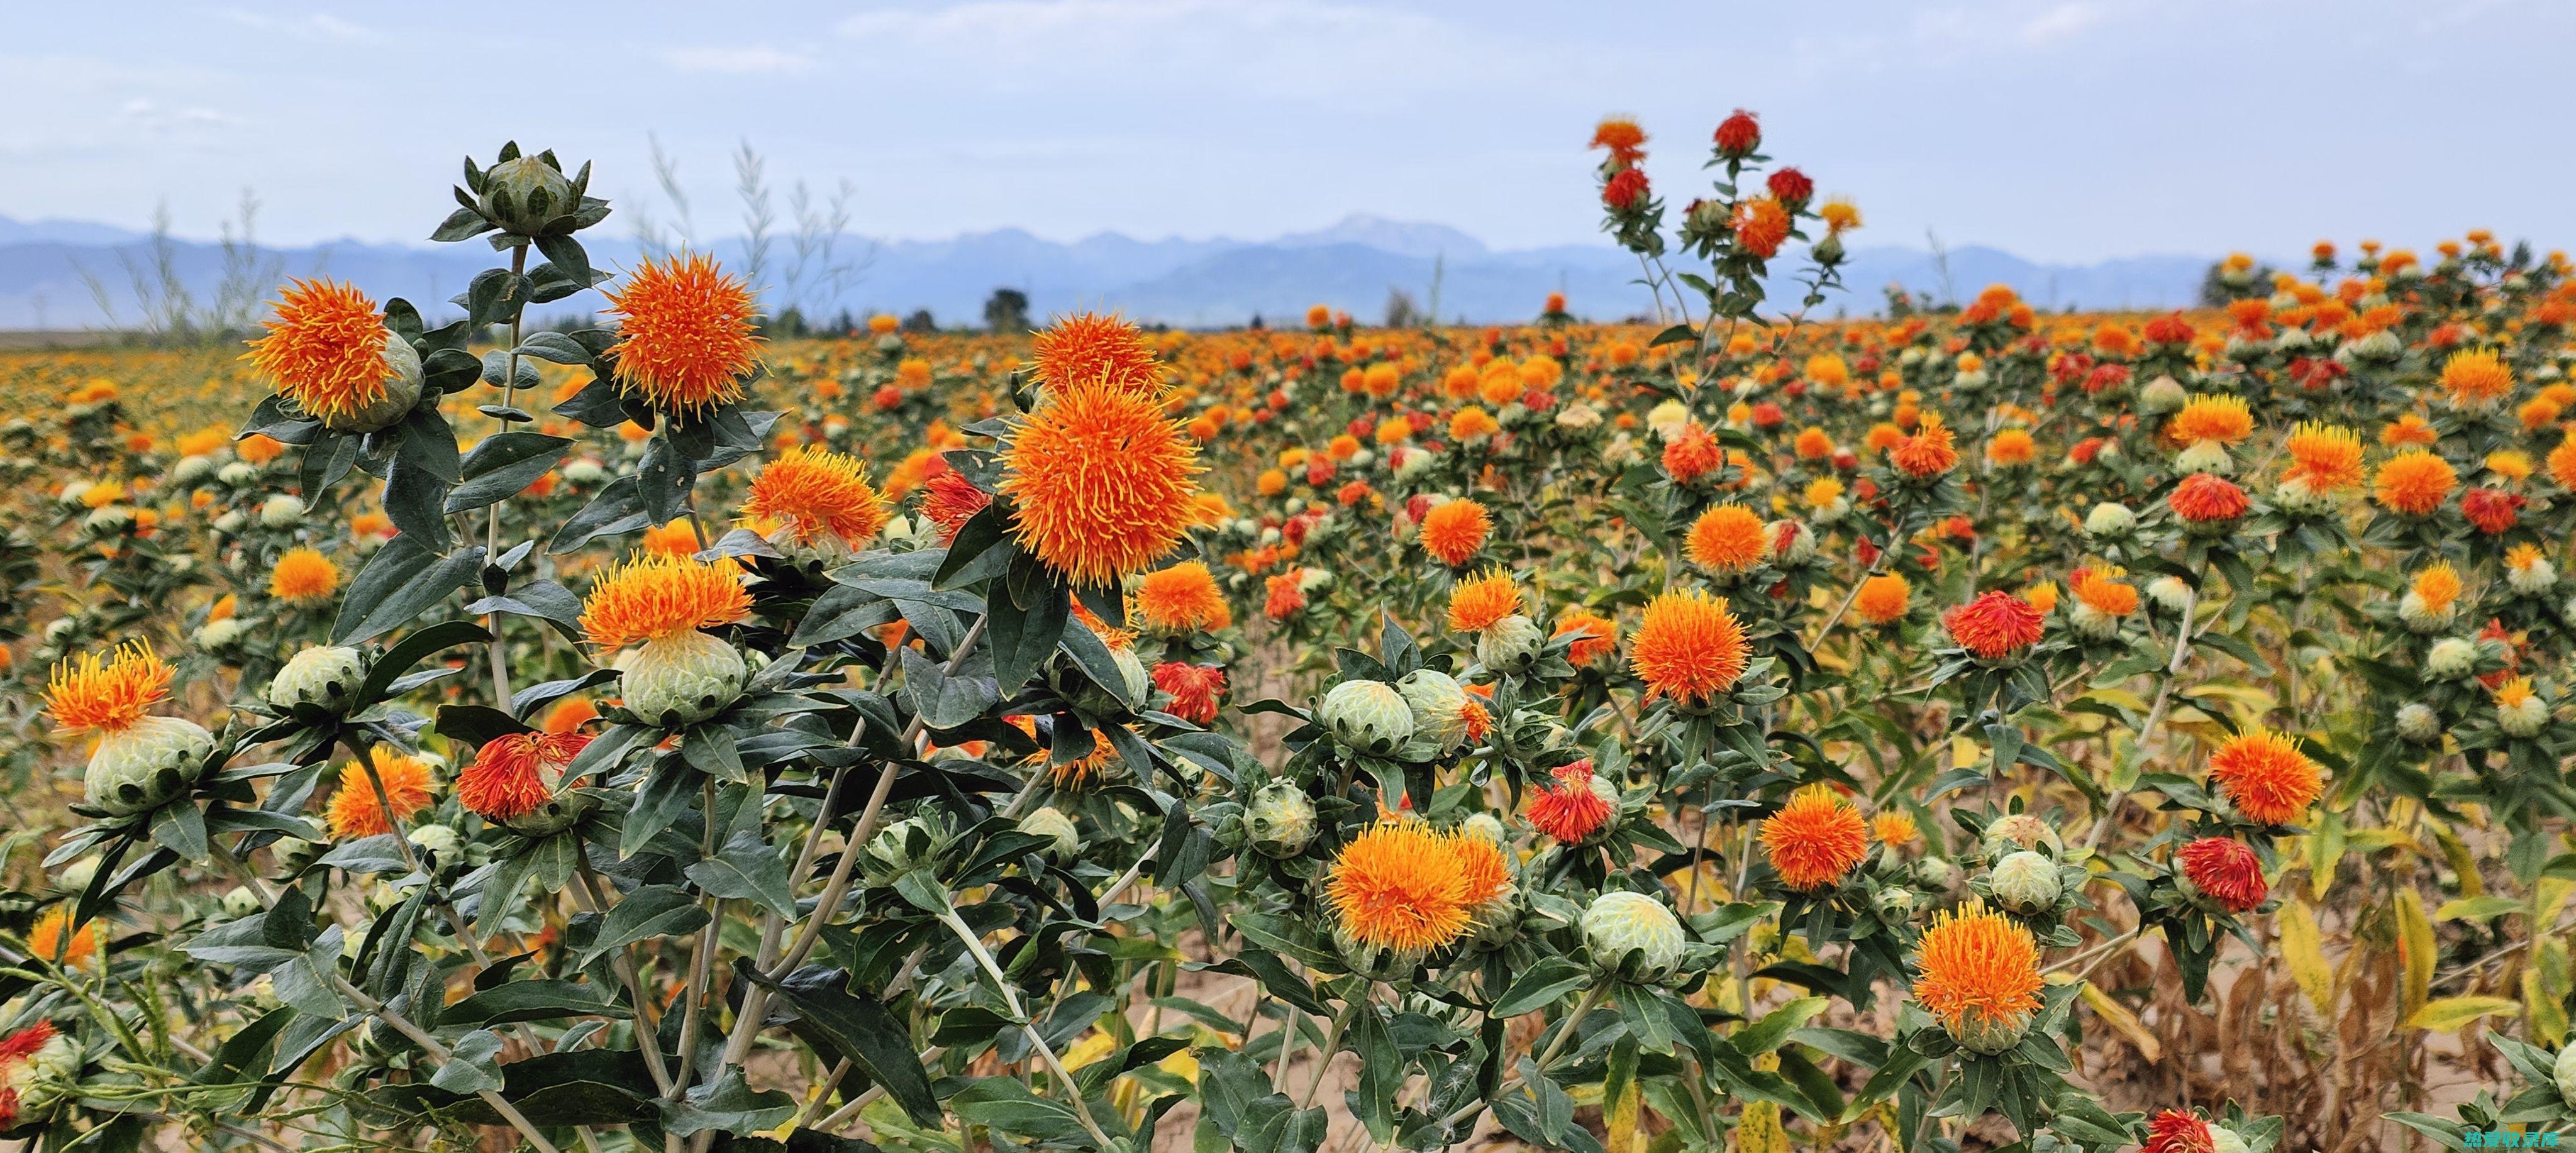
[0,0,2576,260]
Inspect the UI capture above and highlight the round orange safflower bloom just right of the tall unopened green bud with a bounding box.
[600,255,760,414]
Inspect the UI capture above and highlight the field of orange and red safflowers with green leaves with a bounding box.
[0,113,2576,1153]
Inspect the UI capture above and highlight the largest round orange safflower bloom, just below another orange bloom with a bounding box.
[1002,381,1206,584]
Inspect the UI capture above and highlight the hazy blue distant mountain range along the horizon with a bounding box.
[0,216,2210,329]
